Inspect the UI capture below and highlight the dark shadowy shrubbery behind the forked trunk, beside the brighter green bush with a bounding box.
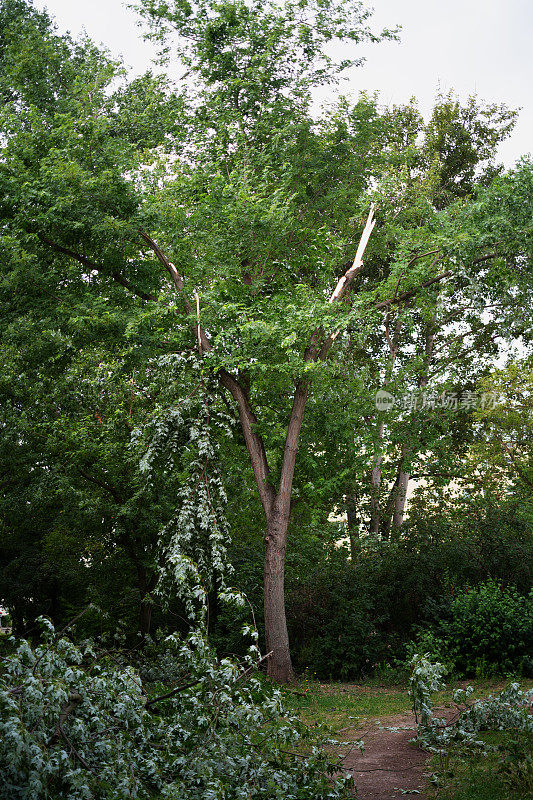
[216,503,533,680]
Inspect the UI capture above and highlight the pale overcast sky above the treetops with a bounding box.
[35,0,533,166]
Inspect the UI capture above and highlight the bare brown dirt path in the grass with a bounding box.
[341,714,428,800]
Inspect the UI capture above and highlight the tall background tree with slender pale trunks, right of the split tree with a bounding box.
[328,96,530,537]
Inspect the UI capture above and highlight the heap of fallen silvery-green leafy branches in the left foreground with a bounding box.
[0,621,356,800]
